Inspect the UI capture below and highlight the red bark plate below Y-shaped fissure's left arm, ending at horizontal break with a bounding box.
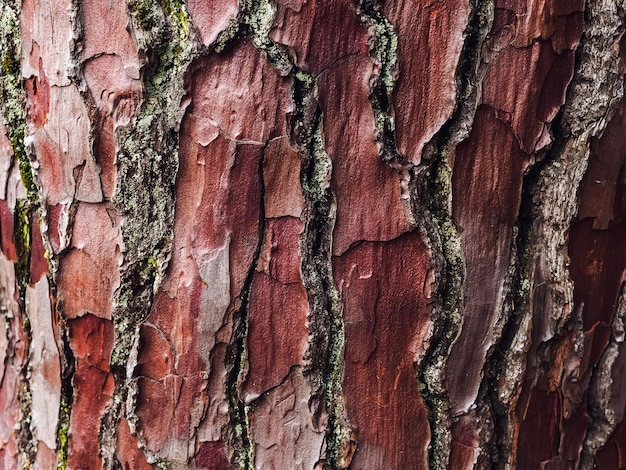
[318,56,412,255]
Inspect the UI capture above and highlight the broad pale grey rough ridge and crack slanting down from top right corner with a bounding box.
[481,2,622,468]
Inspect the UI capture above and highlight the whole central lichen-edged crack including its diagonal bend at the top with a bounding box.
[242,0,356,469]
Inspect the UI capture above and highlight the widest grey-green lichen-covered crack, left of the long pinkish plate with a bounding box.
[100,0,195,468]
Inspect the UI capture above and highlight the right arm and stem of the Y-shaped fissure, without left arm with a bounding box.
[412,2,494,468]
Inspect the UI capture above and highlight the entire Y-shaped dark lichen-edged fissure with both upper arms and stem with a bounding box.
[356,0,493,468]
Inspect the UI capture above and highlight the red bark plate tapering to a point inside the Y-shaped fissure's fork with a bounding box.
[383,0,470,164]
